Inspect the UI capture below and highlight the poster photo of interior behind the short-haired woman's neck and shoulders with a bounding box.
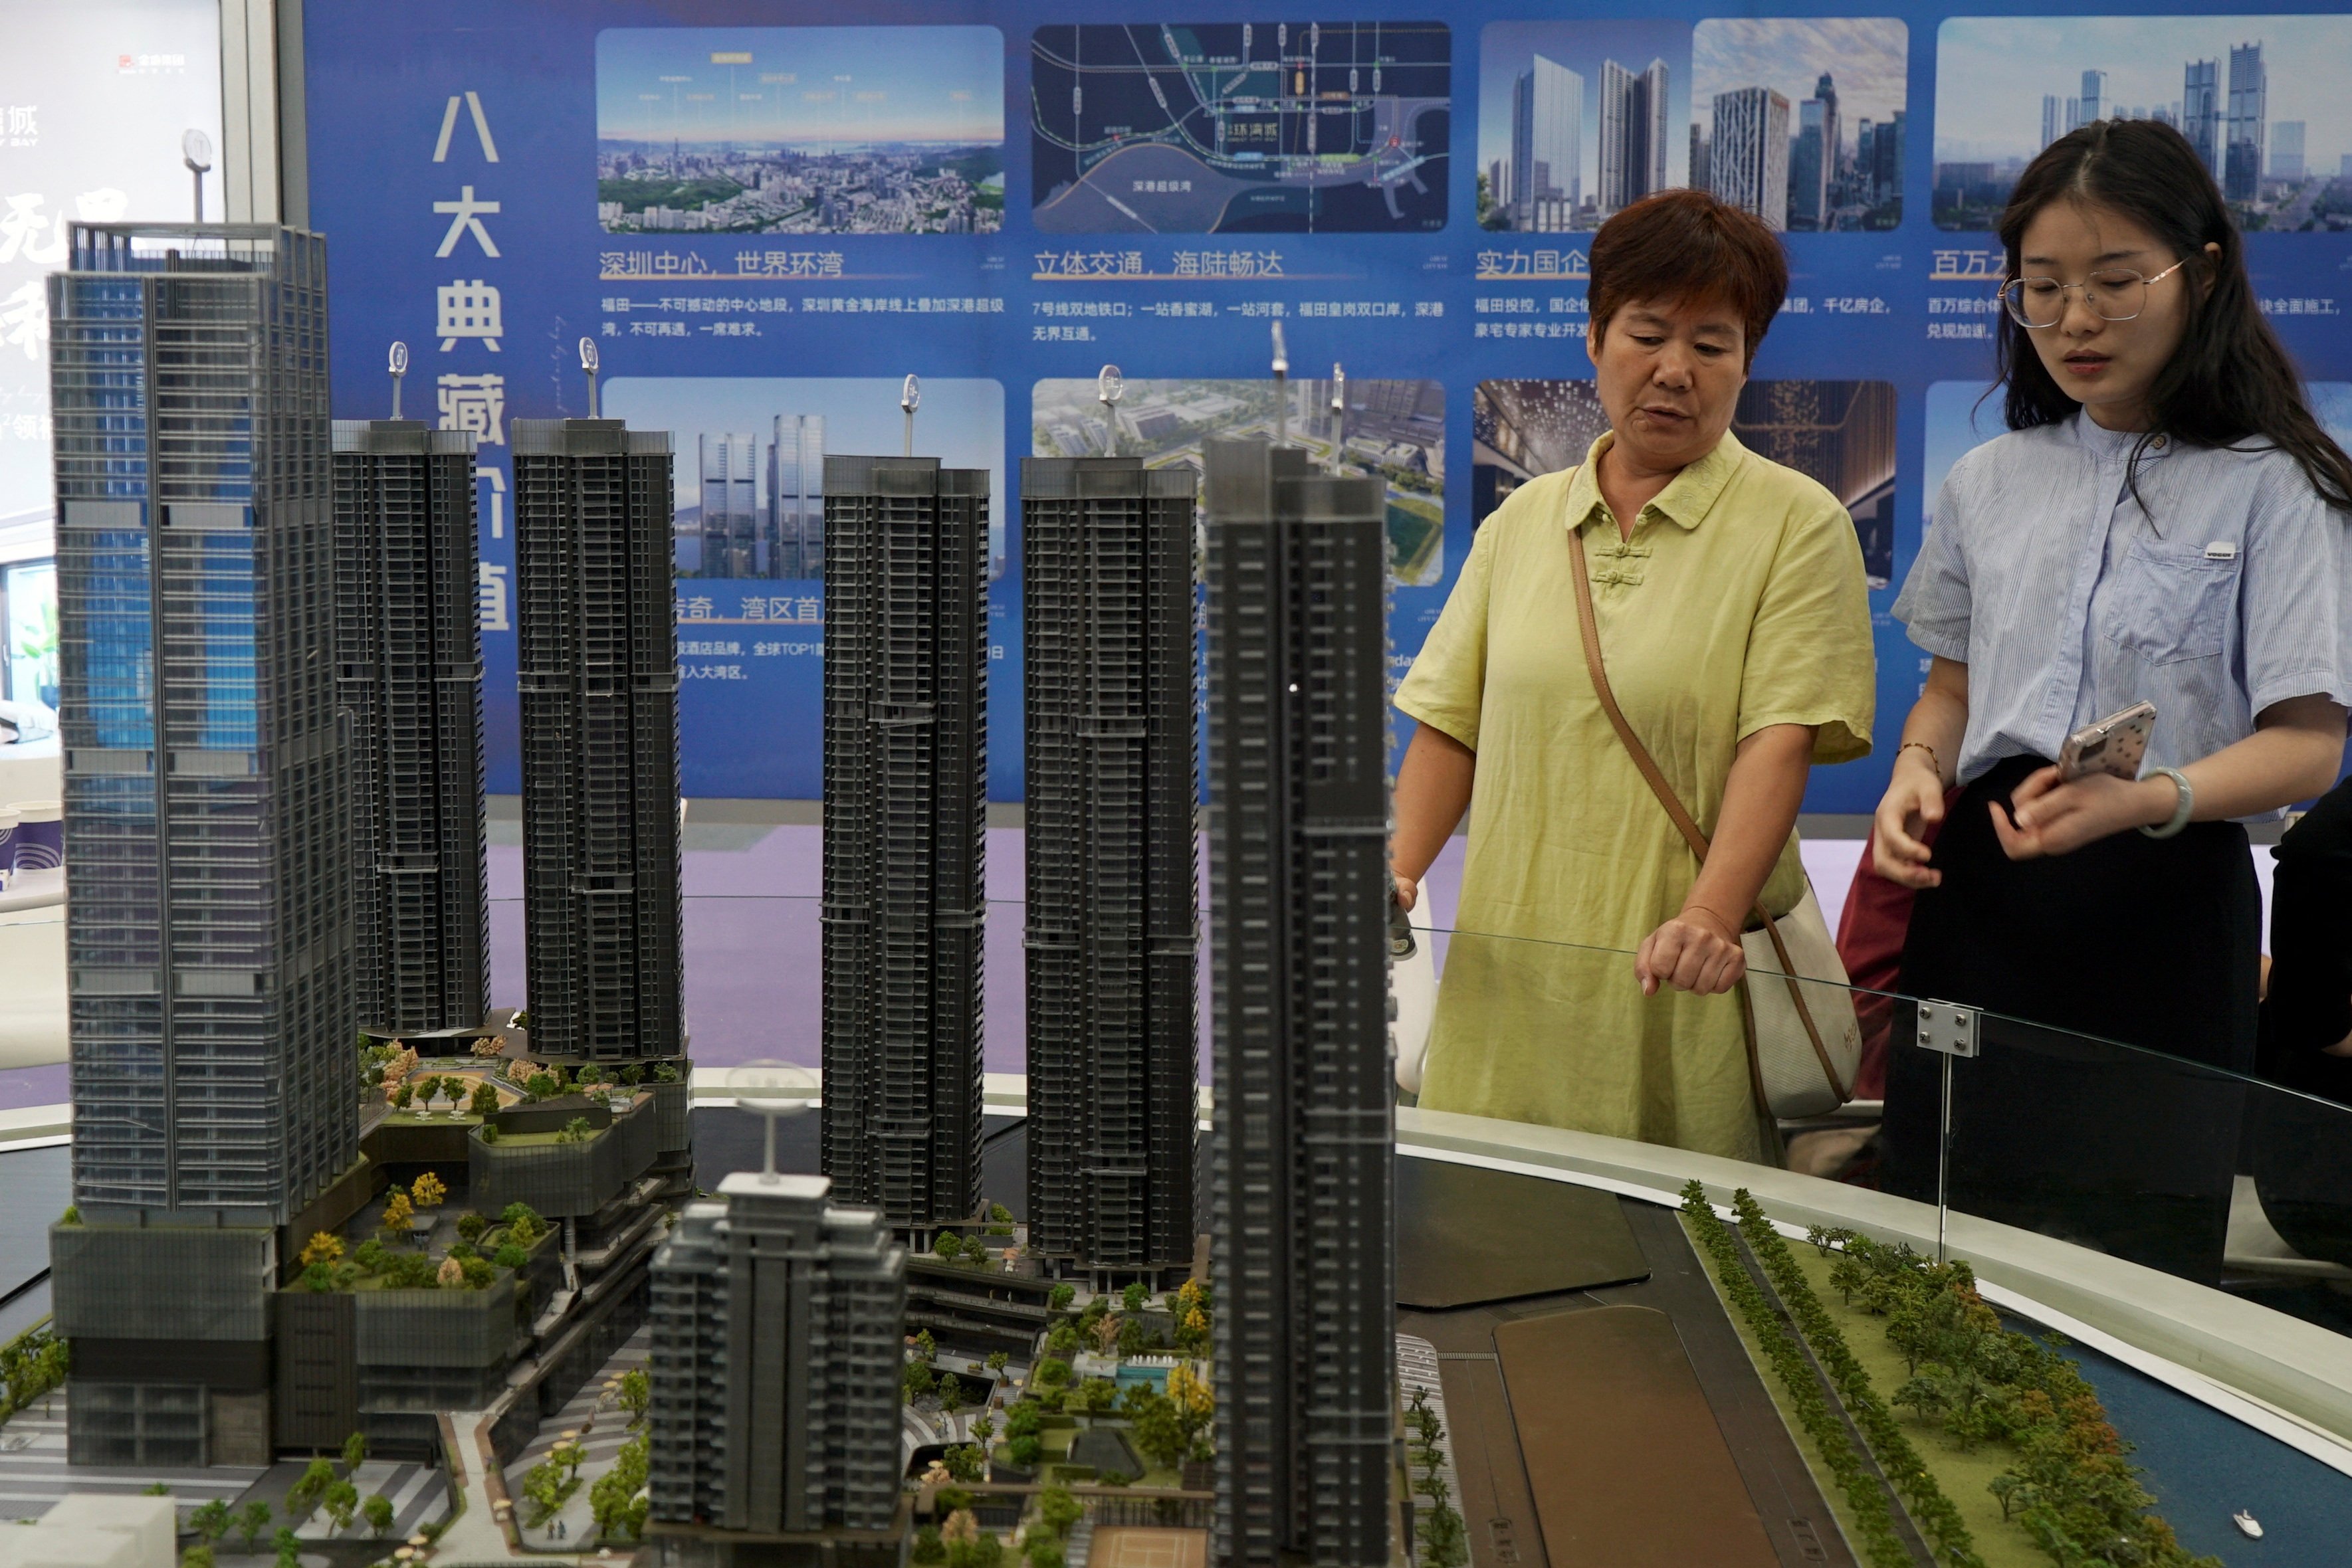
[1470,381,1895,588]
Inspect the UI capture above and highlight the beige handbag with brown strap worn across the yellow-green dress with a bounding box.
[1569,527,1863,1122]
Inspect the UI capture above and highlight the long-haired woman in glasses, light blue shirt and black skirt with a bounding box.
[1875,120,2352,1276]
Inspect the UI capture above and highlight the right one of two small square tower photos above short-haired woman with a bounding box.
[1689,17,1910,233]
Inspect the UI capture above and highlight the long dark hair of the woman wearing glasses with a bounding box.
[1997,120,2352,508]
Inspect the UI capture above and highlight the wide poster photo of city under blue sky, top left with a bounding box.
[595,26,1004,235]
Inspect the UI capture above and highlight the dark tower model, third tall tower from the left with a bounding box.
[508,419,685,1062]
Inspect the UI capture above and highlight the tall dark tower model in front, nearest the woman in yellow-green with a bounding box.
[1207,442,1397,1568]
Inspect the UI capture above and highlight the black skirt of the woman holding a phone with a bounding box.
[1881,757,2263,1284]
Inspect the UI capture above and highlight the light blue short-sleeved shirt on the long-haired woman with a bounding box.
[1893,414,2352,809]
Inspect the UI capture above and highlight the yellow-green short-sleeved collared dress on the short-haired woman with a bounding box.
[1397,435,1875,1159]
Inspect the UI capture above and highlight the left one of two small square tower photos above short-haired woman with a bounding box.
[1477,21,1691,235]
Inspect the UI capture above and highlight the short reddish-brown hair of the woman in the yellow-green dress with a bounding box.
[1585,191,1788,364]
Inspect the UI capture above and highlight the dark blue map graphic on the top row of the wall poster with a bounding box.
[1030,21,1453,235]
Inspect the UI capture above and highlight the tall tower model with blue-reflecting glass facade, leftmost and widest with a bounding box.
[49,223,360,1464]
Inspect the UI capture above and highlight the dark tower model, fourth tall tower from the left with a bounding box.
[823,456,988,1239]
